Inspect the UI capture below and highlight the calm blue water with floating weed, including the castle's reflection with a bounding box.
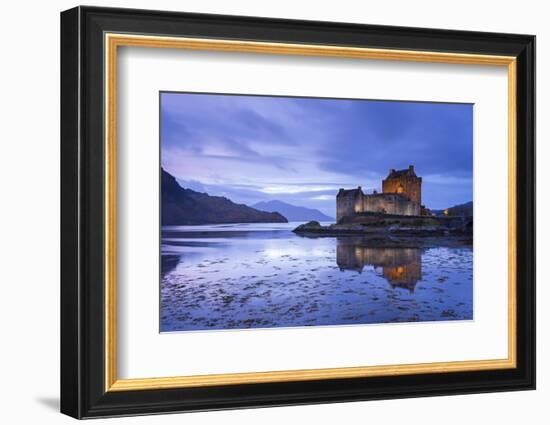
[160,223,473,332]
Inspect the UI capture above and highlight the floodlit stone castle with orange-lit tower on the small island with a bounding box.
[336,165,429,222]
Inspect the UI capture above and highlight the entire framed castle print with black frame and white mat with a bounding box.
[61,7,535,418]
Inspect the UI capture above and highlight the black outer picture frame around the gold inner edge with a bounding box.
[61,7,535,418]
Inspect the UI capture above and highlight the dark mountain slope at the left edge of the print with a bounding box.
[161,170,288,225]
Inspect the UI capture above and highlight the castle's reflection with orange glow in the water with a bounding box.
[336,237,423,293]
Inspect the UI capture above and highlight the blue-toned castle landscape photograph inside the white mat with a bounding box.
[159,92,475,332]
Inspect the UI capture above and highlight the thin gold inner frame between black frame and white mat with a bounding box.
[104,33,517,391]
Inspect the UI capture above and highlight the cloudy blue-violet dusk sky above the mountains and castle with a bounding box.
[161,93,473,217]
